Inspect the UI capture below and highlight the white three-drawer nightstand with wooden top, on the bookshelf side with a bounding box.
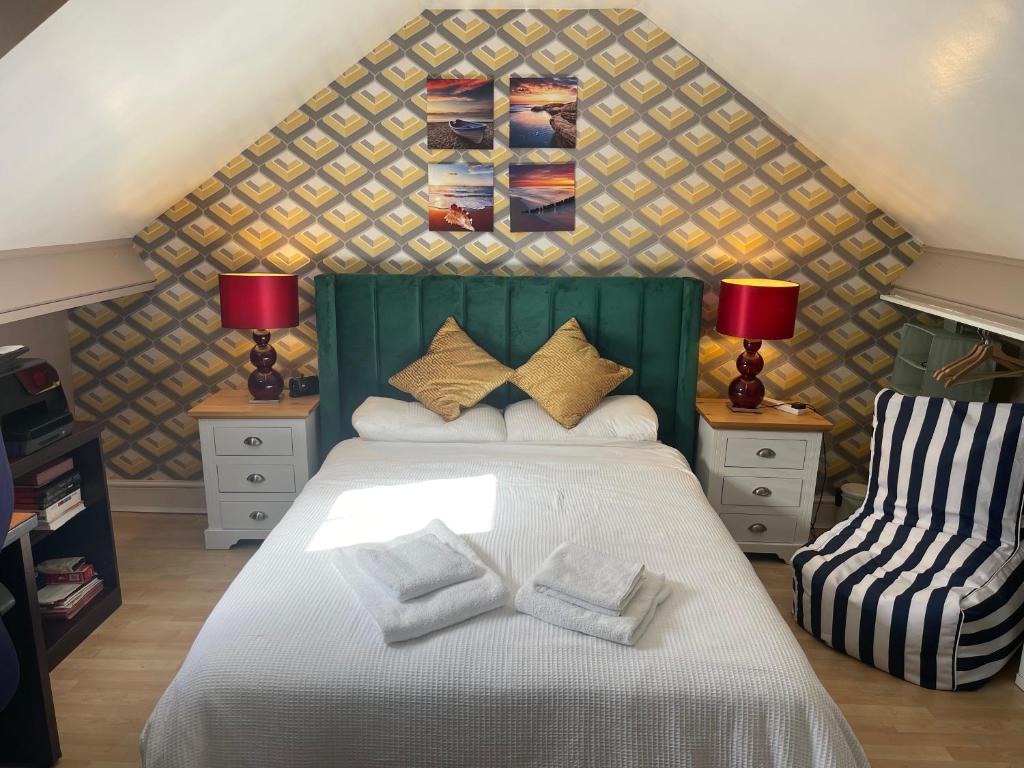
[188,389,319,549]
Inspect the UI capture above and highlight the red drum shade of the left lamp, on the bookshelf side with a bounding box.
[220,272,299,329]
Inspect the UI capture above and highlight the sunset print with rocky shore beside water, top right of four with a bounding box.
[509,77,577,150]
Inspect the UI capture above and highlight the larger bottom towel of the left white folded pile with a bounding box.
[334,520,509,643]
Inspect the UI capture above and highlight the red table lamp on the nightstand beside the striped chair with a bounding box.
[715,278,800,412]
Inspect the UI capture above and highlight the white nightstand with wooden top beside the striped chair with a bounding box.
[695,399,833,560]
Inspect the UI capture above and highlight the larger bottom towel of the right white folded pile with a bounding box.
[515,571,672,645]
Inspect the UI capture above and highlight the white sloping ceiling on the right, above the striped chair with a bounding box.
[640,0,1024,258]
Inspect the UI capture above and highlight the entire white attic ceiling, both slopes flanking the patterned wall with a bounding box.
[0,0,1024,258]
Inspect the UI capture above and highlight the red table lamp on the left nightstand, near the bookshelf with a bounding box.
[219,272,299,402]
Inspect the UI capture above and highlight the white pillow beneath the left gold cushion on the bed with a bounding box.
[352,397,505,442]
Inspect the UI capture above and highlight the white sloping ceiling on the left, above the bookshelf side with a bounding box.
[0,0,420,251]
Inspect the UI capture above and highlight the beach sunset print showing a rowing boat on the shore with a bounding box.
[427,78,495,150]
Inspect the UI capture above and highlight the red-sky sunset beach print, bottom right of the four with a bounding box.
[509,163,575,232]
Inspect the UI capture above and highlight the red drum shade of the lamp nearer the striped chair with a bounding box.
[715,278,800,339]
